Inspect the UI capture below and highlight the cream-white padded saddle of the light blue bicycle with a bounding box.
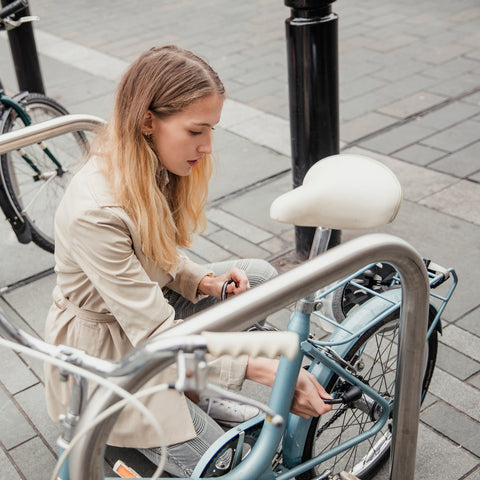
[270,154,402,230]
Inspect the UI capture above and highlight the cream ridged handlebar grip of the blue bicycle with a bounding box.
[202,331,298,360]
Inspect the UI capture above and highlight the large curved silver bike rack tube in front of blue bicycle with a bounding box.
[70,234,429,480]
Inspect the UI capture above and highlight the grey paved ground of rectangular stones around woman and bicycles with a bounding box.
[0,0,480,480]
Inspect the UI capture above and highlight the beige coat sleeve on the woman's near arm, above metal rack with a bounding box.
[69,209,179,346]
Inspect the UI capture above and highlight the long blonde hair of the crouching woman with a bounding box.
[94,45,225,271]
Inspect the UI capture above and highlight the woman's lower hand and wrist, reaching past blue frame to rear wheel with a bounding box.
[245,357,332,418]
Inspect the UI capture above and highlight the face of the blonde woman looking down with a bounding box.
[143,93,223,176]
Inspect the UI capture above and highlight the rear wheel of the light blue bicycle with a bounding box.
[298,306,438,480]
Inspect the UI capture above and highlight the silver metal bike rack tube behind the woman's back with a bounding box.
[0,114,105,154]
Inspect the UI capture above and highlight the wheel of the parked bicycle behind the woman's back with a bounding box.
[0,93,88,252]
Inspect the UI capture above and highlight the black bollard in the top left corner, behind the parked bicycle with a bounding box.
[2,0,45,94]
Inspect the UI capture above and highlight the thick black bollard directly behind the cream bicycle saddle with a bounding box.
[285,0,340,260]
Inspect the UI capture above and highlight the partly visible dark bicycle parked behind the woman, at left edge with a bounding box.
[0,0,88,253]
